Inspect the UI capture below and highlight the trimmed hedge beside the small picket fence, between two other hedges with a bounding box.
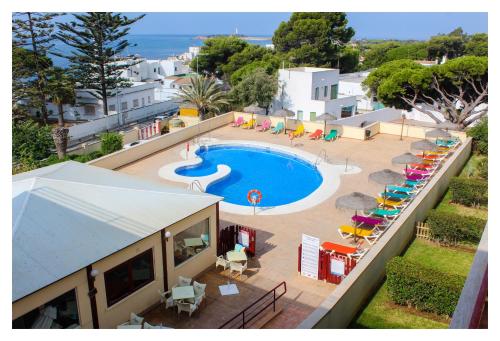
[427,210,486,244]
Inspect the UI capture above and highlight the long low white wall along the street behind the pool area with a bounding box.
[69,101,177,141]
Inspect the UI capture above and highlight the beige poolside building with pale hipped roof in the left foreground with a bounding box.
[12,161,222,328]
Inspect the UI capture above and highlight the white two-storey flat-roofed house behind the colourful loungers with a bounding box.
[271,67,356,121]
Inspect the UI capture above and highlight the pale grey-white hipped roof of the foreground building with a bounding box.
[12,161,222,301]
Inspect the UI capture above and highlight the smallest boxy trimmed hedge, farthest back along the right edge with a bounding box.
[450,177,488,206]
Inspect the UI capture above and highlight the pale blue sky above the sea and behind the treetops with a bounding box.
[52,12,488,40]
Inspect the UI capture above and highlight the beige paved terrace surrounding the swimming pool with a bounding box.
[118,126,417,328]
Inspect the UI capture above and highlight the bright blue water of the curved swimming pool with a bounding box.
[175,145,323,207]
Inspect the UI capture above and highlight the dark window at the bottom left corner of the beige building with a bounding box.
[12,289,80,329]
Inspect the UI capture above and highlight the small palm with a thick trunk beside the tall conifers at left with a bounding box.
[47,67,75,159]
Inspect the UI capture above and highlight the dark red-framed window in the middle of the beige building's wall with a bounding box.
[104,249,154,307]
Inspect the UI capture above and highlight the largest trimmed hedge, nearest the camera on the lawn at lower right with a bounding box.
[386,257,465,316]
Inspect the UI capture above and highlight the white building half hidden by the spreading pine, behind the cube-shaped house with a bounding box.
[339,71,384,112]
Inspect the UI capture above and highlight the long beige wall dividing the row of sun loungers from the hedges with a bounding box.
[297,138,472,328]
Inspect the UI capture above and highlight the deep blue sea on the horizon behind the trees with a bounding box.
[52,34,272,67]
